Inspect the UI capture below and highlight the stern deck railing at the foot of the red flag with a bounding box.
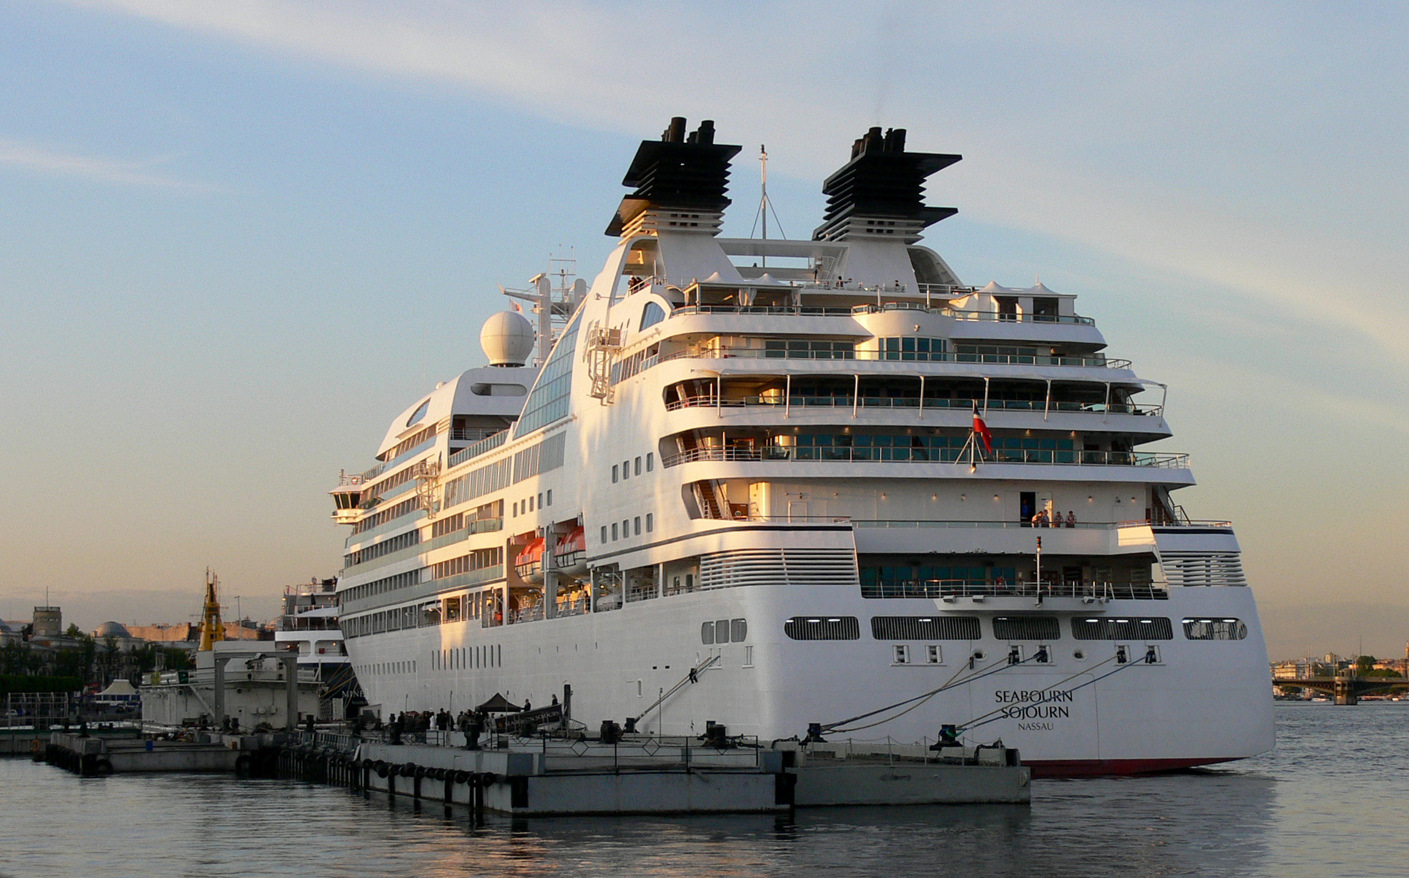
[662,445,1189,469]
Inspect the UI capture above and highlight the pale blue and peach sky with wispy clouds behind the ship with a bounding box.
[0,0,1409,658]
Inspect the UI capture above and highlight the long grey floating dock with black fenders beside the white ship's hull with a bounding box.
[278,736,1031,816]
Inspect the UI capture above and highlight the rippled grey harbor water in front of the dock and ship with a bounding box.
[0,702,1409,878]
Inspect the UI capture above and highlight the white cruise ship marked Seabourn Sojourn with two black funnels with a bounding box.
[331,118,1274,775]
